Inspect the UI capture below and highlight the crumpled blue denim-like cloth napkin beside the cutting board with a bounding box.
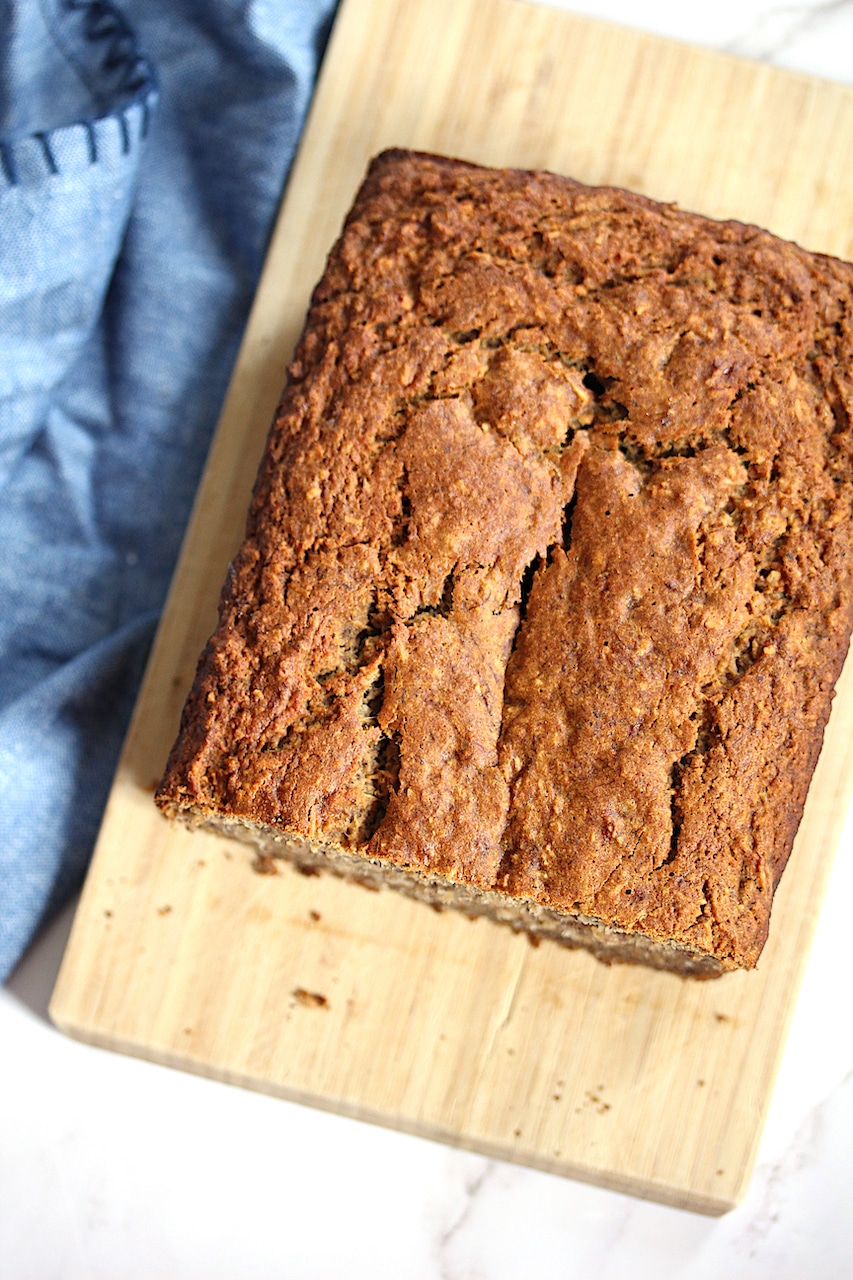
[0,0,334,980]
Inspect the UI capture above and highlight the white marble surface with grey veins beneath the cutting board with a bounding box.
[0,0,853,1280]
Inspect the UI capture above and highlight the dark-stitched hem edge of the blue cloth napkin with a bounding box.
[0,0,159,187]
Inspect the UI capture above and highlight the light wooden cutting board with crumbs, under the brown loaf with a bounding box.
[51,0,853,1213]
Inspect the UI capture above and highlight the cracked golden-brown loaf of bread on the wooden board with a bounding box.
[158,151,853,975]
